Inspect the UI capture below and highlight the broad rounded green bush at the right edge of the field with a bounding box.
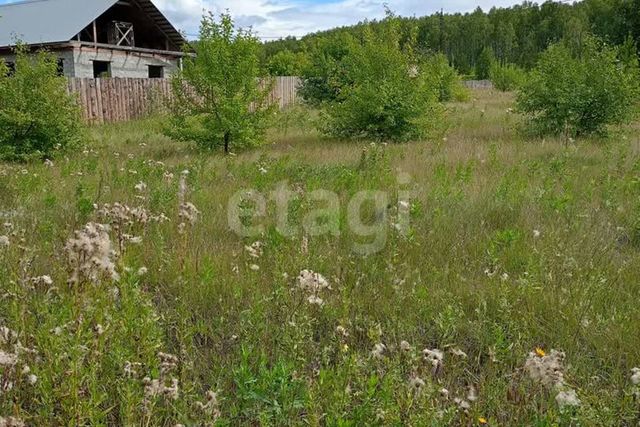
[517,38,638,137]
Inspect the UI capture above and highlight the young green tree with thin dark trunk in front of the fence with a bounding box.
[167,14,275,153]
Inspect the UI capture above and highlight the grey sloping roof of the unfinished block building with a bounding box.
[0,0,185,46]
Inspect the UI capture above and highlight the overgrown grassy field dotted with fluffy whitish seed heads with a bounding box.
[0,91,640,426]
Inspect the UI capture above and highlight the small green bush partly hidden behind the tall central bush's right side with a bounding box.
[421,53,469,102]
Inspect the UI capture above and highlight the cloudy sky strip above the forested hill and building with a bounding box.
[0,0,520,39]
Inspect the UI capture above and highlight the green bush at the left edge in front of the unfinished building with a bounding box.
[0,46,82,161]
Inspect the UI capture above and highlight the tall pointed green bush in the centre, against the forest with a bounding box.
[322,18,440,141]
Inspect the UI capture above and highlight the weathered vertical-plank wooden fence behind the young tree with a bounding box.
[69,77,300,124]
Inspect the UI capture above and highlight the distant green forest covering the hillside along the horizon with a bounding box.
[261,0,640,75]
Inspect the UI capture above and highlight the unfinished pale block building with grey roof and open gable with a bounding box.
[0,0,186,78]
